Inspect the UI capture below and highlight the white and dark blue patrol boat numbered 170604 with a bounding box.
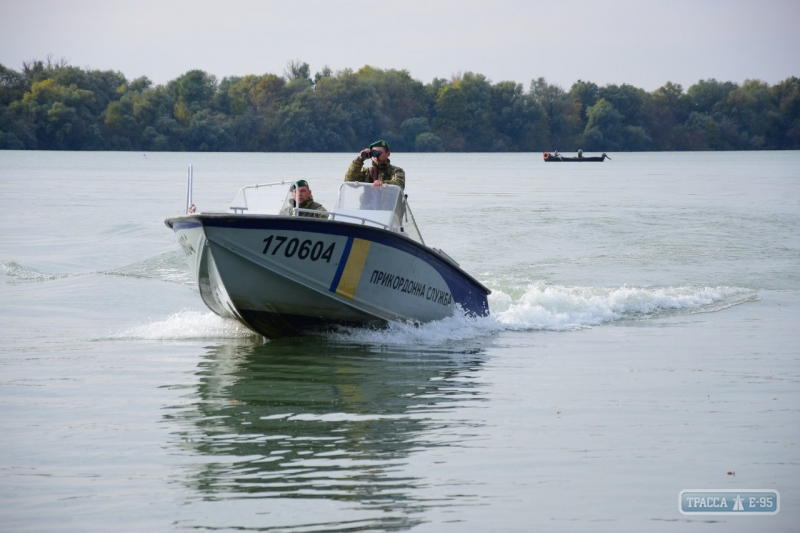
[164,177,491,339]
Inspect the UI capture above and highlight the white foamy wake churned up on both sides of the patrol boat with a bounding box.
[106,282,758,347]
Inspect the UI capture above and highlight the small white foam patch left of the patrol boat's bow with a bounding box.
[105,311,256,340]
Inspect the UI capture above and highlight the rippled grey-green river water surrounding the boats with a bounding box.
[0,151,800,532]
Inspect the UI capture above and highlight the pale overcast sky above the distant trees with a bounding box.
[0,0,800,91]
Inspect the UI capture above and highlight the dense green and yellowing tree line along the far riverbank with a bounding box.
[0,57,800,152]
